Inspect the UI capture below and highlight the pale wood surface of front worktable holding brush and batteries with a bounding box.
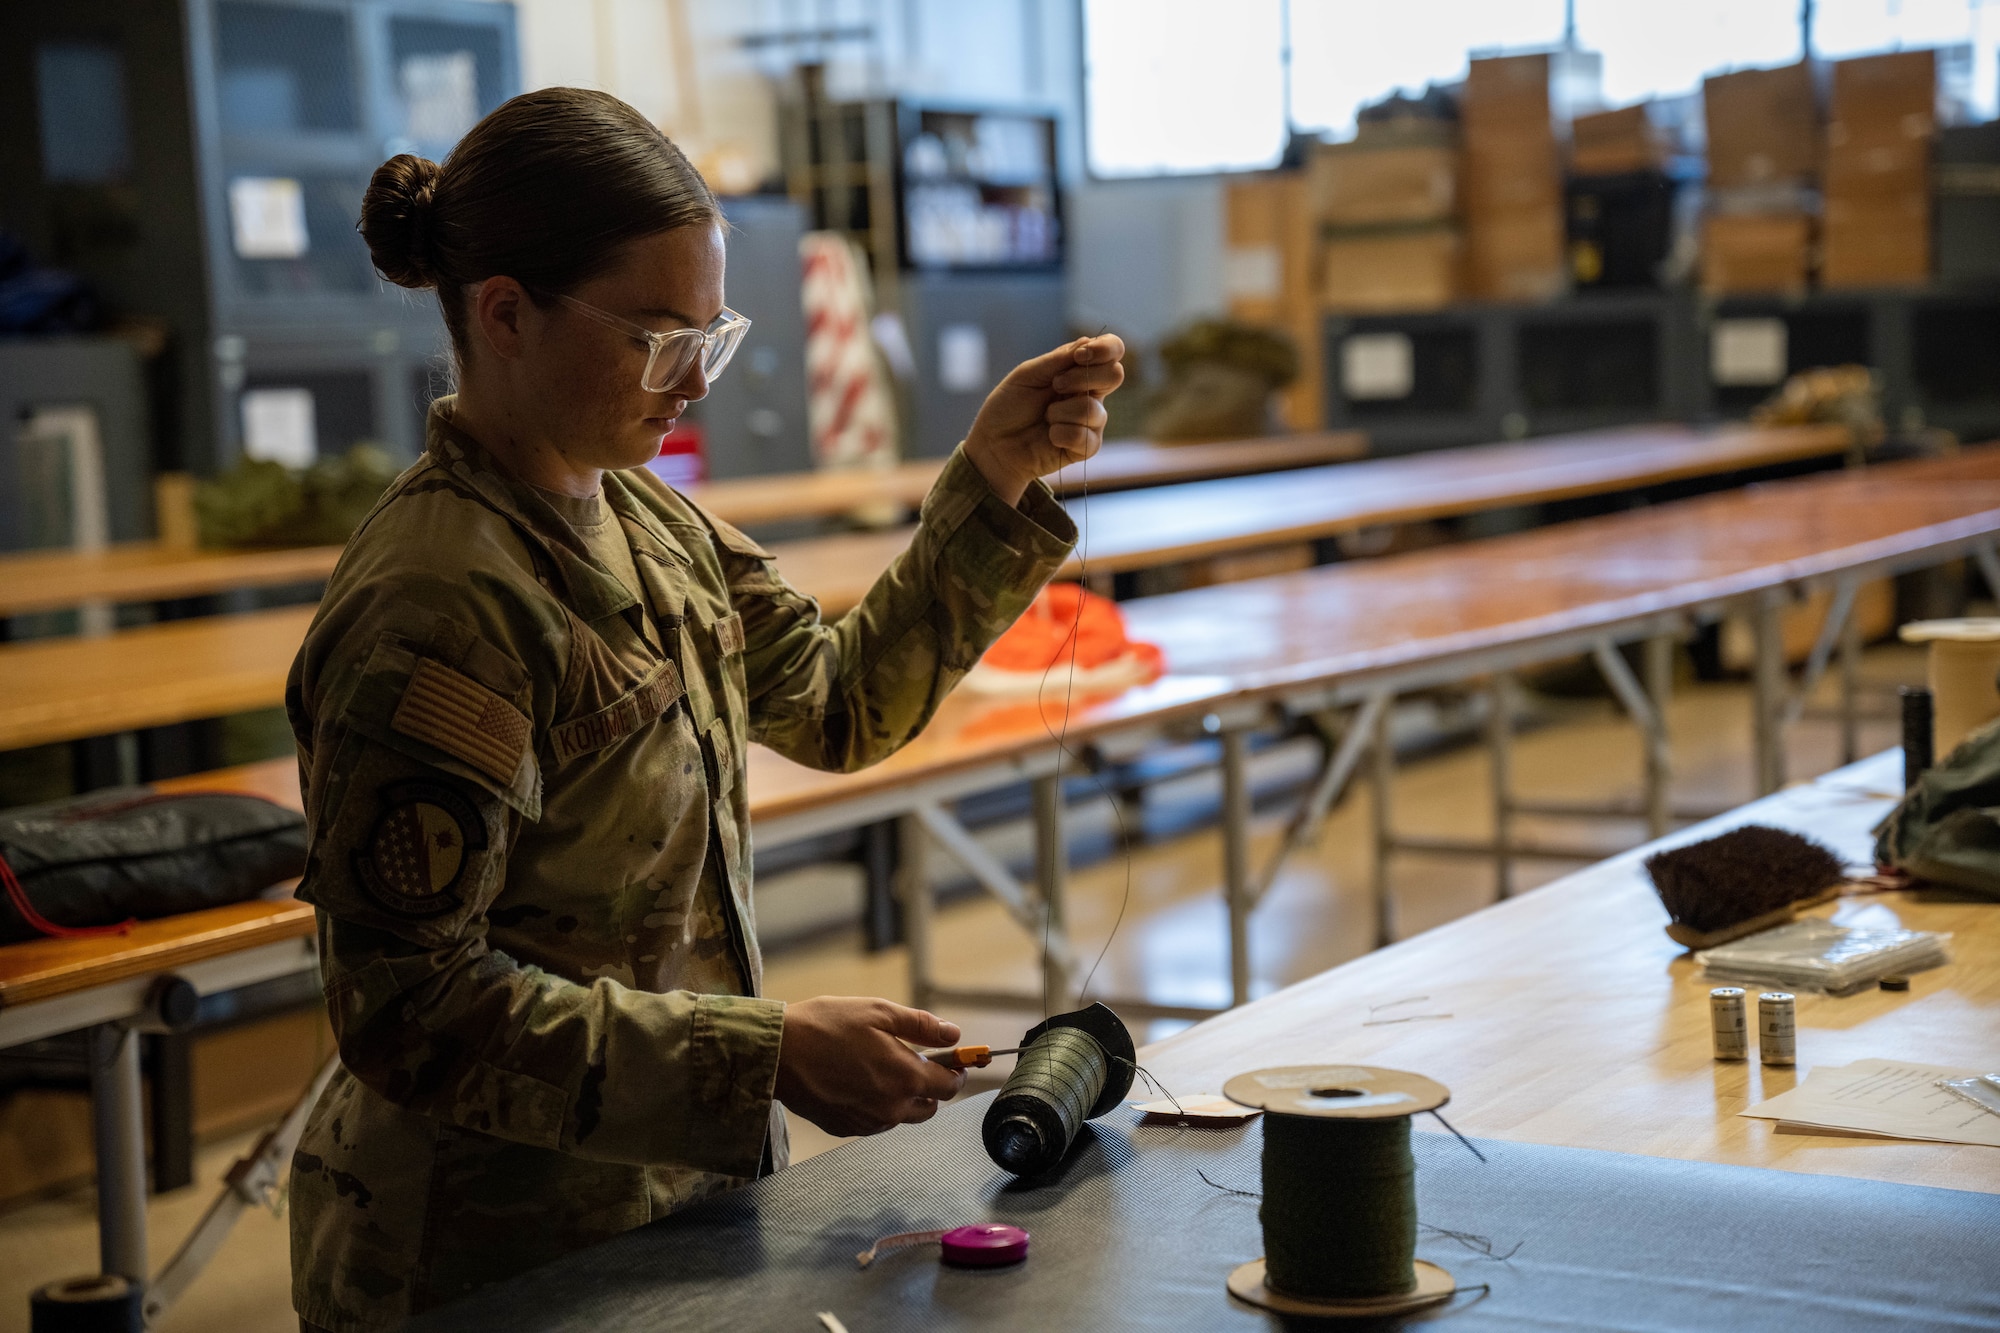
[1140,751,2000,1193]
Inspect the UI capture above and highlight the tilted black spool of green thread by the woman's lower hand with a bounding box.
[980,1001,1138,1175]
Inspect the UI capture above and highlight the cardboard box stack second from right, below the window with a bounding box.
[1702,62,1820,296]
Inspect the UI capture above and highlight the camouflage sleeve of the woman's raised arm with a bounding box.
[714,448,1076,771]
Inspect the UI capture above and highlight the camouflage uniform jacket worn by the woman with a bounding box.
[286,400,1074,1333]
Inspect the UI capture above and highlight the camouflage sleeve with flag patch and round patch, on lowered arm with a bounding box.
[290,572,784,1175]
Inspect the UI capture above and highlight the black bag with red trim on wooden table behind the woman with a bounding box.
[0,787,306,945]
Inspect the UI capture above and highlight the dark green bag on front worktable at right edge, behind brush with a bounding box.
[1876,723,2000,899]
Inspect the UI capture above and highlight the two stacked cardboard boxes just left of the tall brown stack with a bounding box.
[1306,118,1458,314]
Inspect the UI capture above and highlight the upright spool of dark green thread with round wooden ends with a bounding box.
[1222,1065,1458,1317]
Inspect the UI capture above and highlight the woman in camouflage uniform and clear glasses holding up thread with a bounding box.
[288,88,1122,1333]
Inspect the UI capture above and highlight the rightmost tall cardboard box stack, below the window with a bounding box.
[1820,50,1938,286]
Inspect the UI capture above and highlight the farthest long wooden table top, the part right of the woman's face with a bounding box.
[688,430,1368,526]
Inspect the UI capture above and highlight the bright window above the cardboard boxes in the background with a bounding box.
[1084,0,2000,176]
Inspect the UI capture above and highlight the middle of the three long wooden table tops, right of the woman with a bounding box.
[772,426,1850,614]
